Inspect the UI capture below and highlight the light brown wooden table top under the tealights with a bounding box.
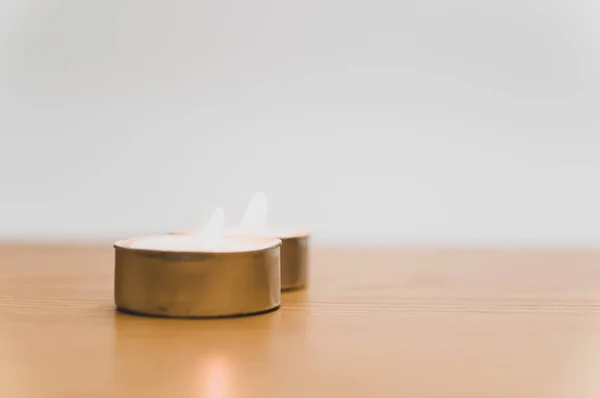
[0,246,600,398]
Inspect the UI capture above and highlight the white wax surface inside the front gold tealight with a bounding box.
[126,235,277,253]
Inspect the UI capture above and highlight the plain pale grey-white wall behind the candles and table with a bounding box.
[0,0,600,245]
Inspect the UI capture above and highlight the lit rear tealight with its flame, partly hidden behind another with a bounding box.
[171,192,310,291]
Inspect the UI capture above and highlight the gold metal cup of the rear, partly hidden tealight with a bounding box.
[171,230,310,291]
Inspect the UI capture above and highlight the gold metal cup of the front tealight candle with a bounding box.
[114,238,281,317]
